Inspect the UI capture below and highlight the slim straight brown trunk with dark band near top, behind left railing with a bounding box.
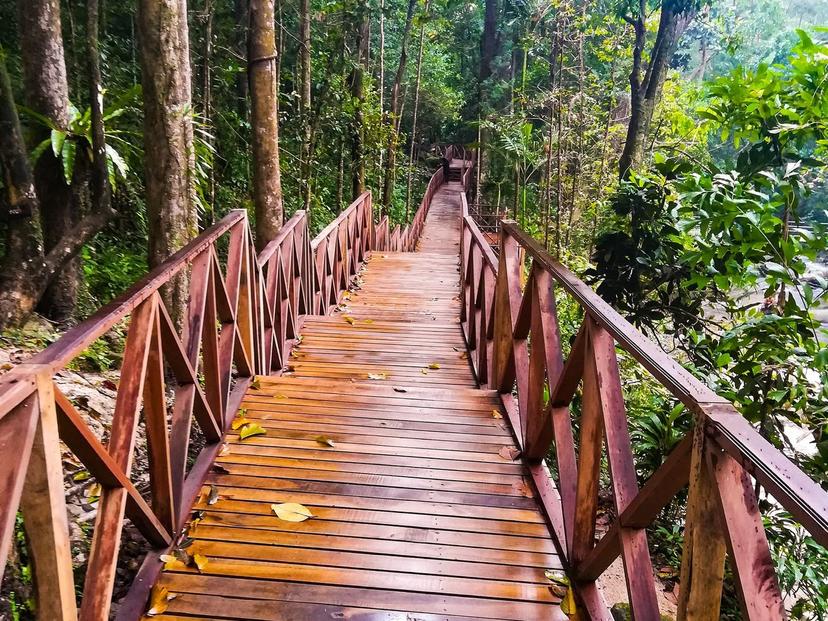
[247,0,284,250]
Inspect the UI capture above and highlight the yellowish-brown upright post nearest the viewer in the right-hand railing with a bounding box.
[678,416,727,621]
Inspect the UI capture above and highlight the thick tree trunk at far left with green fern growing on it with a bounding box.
[18,0,78,323]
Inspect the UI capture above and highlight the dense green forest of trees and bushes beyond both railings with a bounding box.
[0,0,828,620]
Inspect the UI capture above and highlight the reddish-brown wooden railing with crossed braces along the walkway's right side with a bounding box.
[461,208,828,621]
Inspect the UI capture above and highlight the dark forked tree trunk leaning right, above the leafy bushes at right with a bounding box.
[618,0,700,178]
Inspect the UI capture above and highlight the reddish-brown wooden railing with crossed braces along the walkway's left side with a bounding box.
[0,182,442,621]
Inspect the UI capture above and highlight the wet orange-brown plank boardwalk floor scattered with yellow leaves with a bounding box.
[146,177,563,621]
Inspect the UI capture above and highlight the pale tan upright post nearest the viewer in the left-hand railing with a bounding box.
[18,373,78,621]
